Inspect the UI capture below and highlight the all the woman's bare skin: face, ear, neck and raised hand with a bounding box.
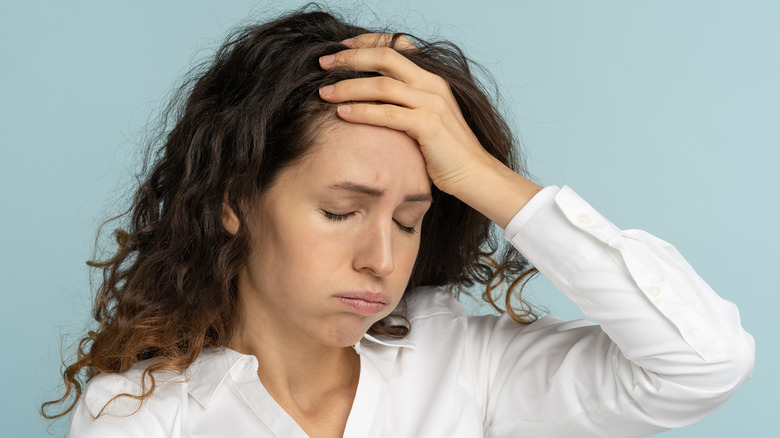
[224,34,541,437]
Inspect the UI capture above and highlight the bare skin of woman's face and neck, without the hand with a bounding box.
[231,121,431,436]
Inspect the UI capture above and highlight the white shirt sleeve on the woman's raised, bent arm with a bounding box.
[468,186,755,437]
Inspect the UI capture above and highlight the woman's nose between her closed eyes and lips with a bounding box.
[353,221,395,277]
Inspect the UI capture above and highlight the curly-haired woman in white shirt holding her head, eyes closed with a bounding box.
[44,6,754,437]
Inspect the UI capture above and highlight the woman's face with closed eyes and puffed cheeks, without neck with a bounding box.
[239,121,431,347]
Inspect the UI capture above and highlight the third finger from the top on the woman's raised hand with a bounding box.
[320,76,428,108]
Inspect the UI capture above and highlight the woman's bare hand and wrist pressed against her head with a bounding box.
[320,34,541,228]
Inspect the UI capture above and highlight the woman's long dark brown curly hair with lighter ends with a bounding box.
[41,6,535,419]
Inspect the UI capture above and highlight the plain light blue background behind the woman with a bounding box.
[0,0,780,437]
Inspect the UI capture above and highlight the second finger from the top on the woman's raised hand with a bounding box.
[320,47,434,88]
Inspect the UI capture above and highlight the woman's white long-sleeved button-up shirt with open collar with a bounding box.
[69,187,755,438]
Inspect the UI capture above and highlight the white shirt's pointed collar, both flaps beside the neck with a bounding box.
[186,333,415,408]
